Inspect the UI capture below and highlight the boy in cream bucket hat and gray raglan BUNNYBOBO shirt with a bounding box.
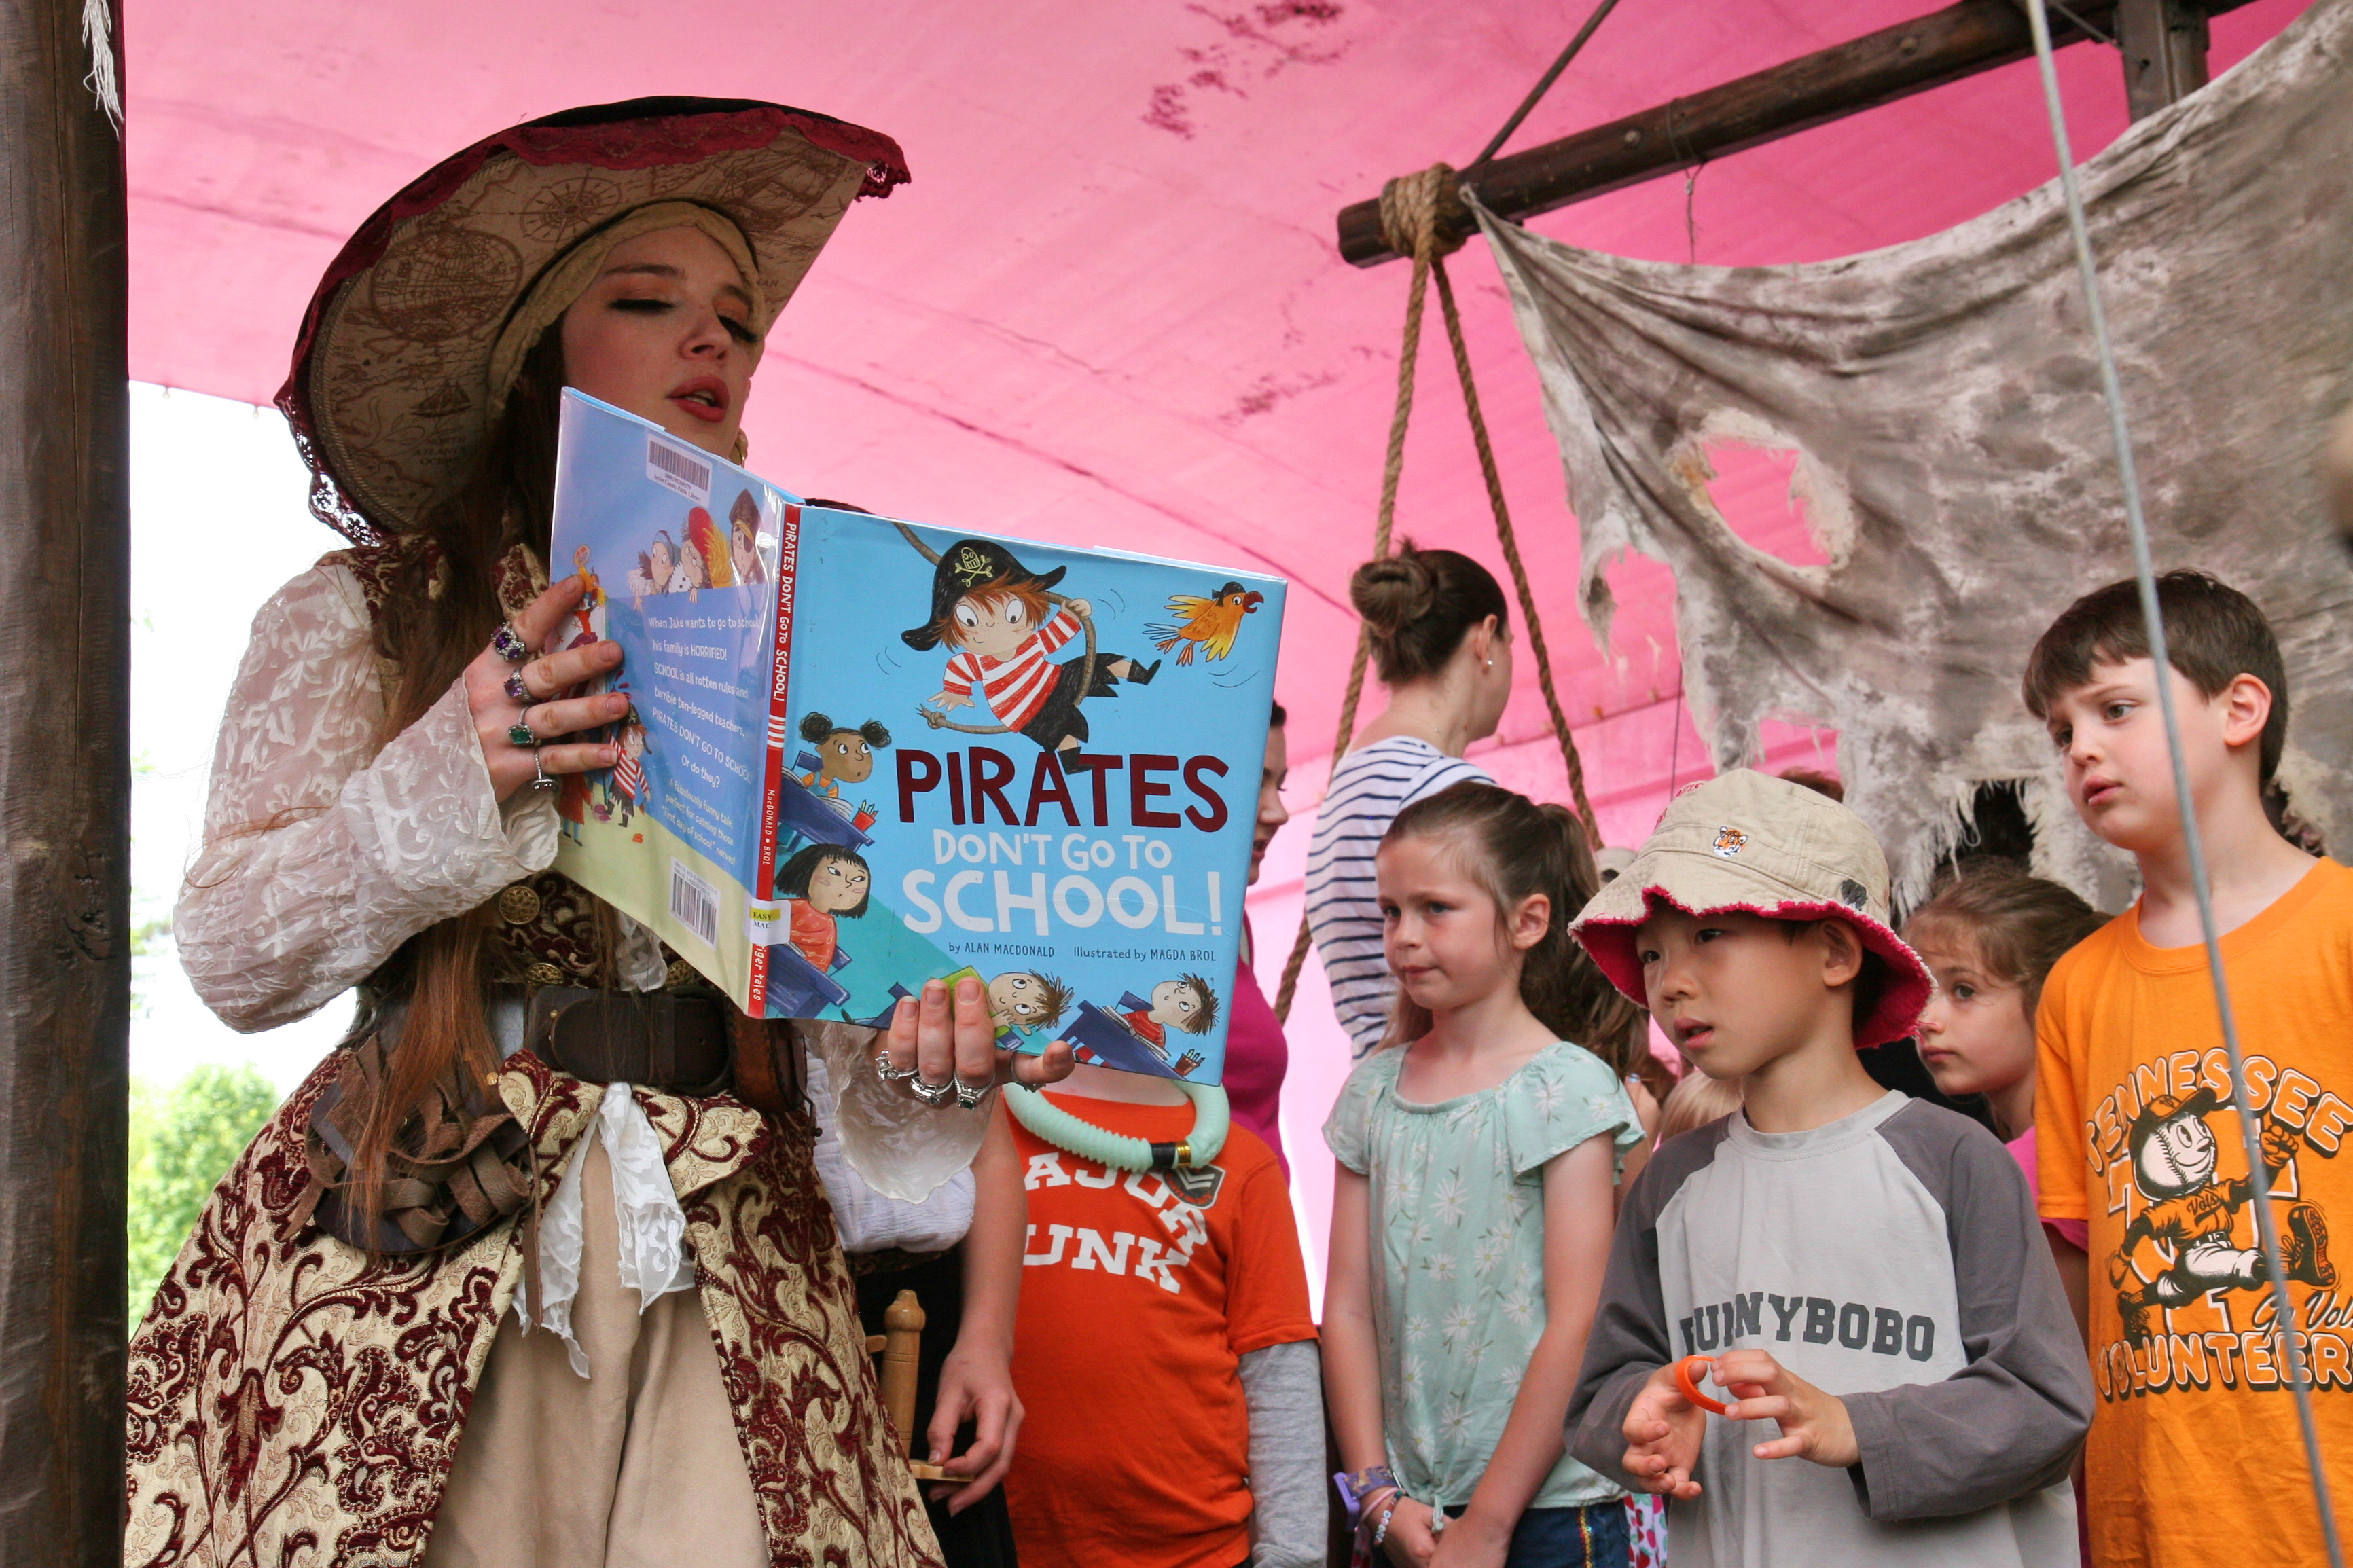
[1569,769,2091,1568]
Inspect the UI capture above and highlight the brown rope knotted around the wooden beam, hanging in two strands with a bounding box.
[1275,162,1602,1020]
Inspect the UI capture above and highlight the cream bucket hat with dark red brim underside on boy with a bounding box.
[1569,769,1937,1049]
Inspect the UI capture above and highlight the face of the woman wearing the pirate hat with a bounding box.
[562,228,760,456]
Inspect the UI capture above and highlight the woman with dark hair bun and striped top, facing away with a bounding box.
[1306,541,1511,1055]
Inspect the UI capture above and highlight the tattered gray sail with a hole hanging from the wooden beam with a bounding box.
[1480,0,2353,907]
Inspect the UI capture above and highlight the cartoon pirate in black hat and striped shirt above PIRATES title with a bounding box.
[899,539,1160,752]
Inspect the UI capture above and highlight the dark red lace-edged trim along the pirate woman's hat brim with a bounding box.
[273,103,913,522]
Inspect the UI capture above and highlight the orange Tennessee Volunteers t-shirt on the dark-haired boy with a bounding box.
[2035,860,2353,1568]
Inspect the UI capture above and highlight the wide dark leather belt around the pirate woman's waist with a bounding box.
[520,985,732,1095]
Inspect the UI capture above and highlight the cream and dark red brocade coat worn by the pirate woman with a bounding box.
[122,543,939,1568]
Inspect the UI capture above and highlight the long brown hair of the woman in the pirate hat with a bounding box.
[348,322,564,1237]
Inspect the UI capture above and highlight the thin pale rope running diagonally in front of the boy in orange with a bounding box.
[2026,0,2346,1568]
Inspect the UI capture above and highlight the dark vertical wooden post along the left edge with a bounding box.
[0,0,130,1568]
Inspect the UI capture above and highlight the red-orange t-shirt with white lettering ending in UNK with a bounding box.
[1005,1095,1315,1568]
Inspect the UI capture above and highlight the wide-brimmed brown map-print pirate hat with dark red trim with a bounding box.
[278,98,908,543]
